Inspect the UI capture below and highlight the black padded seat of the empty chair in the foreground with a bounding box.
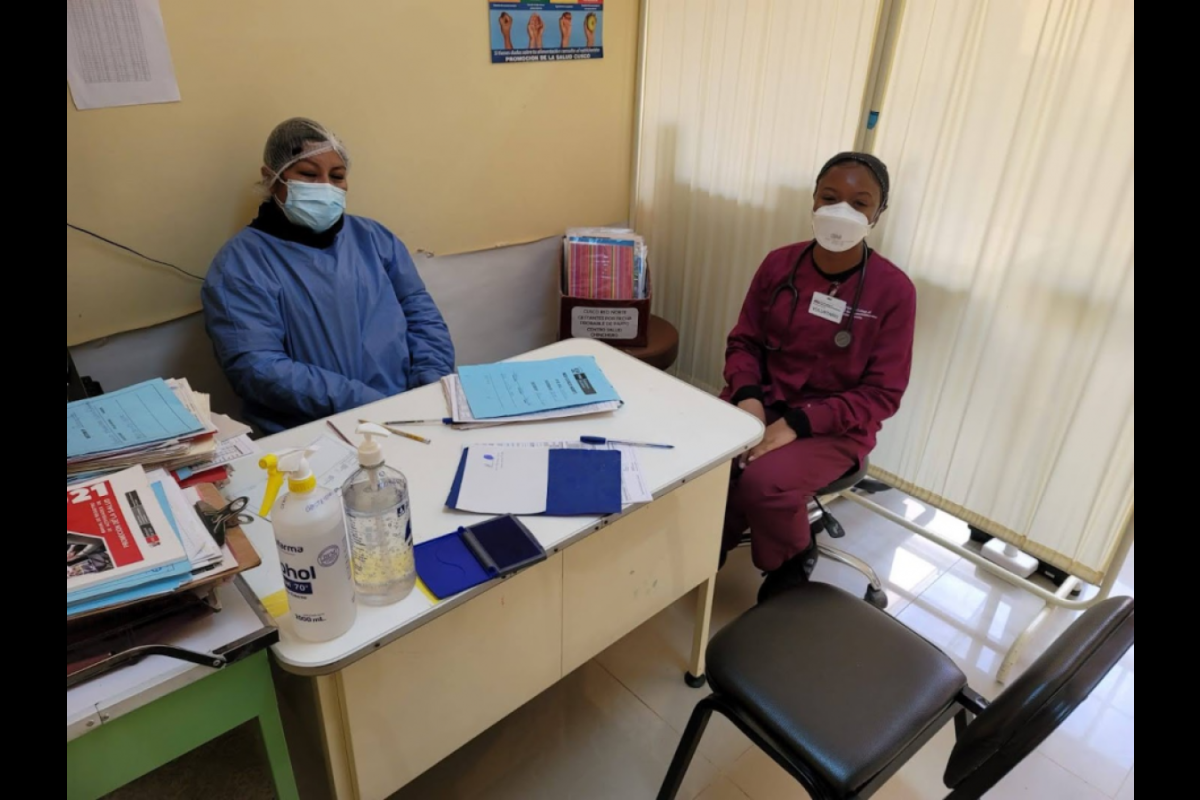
[708,583,967,795]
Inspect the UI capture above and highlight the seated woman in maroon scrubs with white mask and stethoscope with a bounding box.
[724,152,917,601]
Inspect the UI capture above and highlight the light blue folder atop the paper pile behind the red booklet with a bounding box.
[67,380,204,461]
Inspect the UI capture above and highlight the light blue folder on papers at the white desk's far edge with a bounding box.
[442,356,622,428]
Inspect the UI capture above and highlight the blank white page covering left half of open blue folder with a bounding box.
[458,445,550,515]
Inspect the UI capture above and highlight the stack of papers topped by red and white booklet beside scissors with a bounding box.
[67,467,238,619]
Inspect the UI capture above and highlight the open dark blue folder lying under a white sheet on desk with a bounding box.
[446,447,623,517]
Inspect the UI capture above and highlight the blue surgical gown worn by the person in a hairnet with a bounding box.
[203,216,455,433]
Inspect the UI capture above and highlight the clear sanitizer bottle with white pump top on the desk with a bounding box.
[342,423,416,606]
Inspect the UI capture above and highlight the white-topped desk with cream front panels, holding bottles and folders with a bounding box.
[237,339,763,800]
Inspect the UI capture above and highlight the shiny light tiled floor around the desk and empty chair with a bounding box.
[394,493,1134,800]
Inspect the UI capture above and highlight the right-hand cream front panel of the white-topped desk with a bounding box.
[563,467,730,674]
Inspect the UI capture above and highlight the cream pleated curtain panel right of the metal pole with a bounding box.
[868,0,1134,582]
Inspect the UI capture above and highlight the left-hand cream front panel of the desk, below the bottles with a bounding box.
[341,555,563,800]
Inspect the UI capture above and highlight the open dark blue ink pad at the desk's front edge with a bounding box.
[415,517,546,600]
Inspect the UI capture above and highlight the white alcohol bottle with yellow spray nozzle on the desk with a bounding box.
[259,450,358,643]
